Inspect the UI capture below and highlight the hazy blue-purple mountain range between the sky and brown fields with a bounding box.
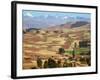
[22,16,90,29]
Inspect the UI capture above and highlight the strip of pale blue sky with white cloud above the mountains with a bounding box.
[23,10,90,18]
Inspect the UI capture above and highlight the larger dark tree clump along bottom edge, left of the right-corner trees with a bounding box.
[32,57,73,69]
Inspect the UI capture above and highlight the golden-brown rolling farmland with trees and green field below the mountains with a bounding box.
[23,24,91,69]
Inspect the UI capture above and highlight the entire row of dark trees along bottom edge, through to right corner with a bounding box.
[31,54,91,69]
